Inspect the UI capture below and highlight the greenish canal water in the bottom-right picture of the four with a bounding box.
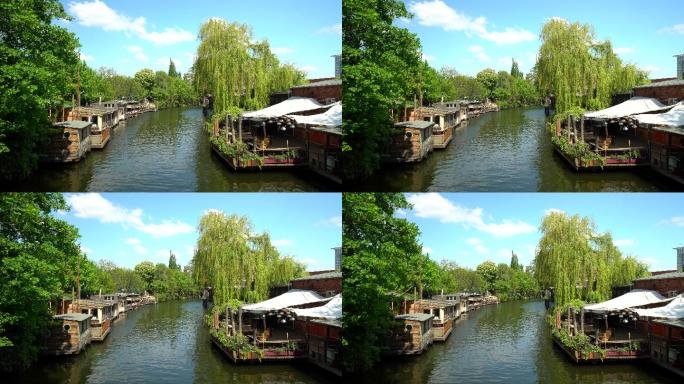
[357,301,680,384]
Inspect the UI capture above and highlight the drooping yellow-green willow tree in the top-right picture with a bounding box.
[536,19,647,113]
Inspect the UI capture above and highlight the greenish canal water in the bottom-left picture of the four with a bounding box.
[9,301,330,384]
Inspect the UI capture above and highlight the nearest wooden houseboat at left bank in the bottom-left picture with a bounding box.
[44,313,92,355]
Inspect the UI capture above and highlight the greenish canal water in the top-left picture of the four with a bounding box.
[0,108,328,192]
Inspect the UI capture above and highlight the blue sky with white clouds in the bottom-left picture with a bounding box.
[55,193,342,271]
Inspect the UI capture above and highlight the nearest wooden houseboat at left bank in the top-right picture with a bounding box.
[384,121,435,163]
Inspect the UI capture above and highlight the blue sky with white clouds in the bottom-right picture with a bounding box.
[404,193,684,271]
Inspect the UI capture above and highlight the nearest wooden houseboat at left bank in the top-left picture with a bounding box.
[43,121,93,163]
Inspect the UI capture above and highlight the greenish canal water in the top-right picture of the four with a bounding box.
[356,108,681,192]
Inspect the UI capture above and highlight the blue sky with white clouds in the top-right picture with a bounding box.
[396,0,684,78]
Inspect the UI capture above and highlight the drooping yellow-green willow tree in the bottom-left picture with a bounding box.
[193,211,303,305]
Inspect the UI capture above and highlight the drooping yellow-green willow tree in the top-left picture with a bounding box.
[194,19,303,113]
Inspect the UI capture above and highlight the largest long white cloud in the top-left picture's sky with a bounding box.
[69,0,195,45]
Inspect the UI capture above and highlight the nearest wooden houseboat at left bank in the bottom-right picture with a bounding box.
[388,313,433,355]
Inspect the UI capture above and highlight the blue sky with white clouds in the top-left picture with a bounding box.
[57,0,342,78]
